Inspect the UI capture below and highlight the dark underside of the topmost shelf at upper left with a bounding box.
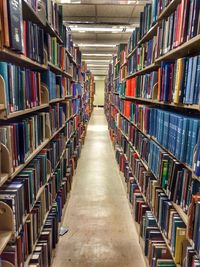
[22,0,46,28]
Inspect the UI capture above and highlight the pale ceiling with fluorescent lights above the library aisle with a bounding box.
[58,0,151,75]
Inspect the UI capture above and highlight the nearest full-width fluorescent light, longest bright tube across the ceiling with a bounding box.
[70,26,135,33]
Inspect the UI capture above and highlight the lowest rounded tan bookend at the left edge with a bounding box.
[0,201,14,254]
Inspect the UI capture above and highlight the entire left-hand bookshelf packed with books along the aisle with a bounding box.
[0,0,94,266]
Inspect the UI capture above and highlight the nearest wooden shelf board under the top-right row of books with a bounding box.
[155,34,200,63]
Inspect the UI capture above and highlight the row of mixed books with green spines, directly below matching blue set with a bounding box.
[118,117,200,207]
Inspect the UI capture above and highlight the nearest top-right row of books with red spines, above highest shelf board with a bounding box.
[157,0,200,57]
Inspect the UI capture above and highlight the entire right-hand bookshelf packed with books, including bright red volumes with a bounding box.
[105,0,200,267]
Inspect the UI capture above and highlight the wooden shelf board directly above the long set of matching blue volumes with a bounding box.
[121,96,200,111]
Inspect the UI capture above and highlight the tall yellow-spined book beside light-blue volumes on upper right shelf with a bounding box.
[174,58,184,104]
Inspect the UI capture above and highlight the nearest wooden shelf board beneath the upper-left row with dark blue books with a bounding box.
[0,48,47,70]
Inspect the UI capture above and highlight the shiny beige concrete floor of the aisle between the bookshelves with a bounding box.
[53,108,145,267]
